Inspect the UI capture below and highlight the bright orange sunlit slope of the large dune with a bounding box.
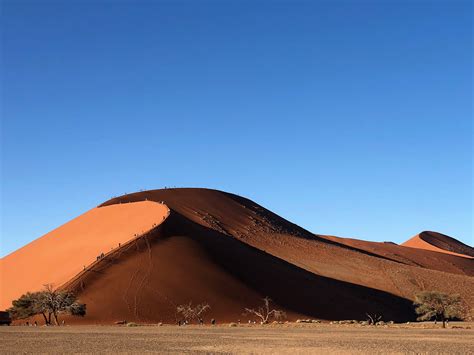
[0,201,168,309]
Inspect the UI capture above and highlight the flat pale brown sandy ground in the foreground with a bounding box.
[0,323,474,354]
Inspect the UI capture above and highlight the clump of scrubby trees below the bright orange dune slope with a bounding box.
[7,284,86,325]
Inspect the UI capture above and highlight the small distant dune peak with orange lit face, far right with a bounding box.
[402,231,474,258]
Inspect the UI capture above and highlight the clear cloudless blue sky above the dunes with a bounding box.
[0,0,473,255]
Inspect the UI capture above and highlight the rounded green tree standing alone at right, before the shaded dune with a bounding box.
[414,291,465,328]
